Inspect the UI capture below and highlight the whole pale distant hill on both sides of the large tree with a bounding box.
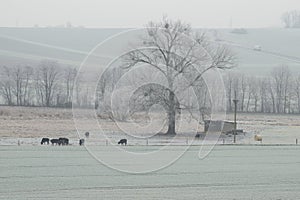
[0,28,300,75]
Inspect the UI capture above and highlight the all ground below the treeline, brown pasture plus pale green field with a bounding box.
[0,107,300,200]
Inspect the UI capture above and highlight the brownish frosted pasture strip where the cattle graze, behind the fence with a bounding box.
[0,106,300,145]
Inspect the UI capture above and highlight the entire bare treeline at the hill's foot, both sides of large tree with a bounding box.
[0,60,300,113]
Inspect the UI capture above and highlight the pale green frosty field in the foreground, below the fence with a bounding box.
[0,145,300,200]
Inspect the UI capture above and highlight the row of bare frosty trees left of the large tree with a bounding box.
[0,60,92,107]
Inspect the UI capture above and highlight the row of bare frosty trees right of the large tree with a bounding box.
[225,66,300,113]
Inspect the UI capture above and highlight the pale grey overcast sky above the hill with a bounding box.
[0,0,300,28]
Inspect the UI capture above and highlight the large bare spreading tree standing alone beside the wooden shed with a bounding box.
[125,18,234,135]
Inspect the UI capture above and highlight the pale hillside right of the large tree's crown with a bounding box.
[219,29,300,74]
